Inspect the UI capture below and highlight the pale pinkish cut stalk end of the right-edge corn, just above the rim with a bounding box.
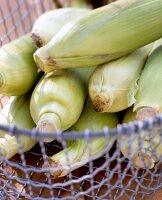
[136,107,160,120]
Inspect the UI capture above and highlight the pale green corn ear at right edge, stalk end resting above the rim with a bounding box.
[133,39,162,120]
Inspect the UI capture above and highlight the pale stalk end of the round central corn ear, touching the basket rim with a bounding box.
[37,113,60,142]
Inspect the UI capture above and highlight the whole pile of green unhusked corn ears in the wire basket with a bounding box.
[0,0,162,173]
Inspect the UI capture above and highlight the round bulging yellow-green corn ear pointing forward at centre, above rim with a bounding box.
[30,67,94,142]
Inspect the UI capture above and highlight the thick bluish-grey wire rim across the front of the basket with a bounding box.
[0,114,162,140]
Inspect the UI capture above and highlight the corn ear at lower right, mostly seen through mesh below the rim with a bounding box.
[118,108,162,169]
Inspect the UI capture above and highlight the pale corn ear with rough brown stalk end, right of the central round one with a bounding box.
[89,44,153,112]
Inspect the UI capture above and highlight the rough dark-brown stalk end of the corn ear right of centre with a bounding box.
[92,95,110,112]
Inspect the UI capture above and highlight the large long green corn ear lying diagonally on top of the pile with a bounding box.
[34,0,162,72]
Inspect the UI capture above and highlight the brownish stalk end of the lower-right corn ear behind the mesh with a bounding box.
[133,153,155,169]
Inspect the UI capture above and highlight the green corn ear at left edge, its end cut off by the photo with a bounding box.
[0,35,39,96]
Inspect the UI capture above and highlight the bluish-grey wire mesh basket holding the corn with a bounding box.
[0,0,162,200]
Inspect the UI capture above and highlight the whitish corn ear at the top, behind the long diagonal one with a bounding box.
[32,8,89,47]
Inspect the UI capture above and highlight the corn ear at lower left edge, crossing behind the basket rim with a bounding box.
[0,95,36,159]
